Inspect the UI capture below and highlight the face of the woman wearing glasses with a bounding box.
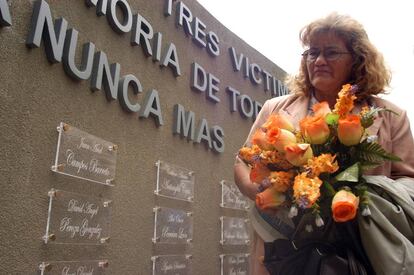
[304,32,353,97]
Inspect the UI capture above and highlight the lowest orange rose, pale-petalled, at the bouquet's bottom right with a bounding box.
[332,190,359,222]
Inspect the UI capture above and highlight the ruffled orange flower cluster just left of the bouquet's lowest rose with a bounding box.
[293,173,322,208]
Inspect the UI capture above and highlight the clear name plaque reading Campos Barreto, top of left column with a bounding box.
[52,122,118,185]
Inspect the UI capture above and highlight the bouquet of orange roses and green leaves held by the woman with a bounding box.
[239,84,401,227]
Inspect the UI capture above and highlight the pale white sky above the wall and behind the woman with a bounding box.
[198,0,414,126]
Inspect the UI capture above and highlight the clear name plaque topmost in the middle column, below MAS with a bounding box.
[154,160,195,202]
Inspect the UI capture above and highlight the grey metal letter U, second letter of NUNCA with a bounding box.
[63,29,95,80]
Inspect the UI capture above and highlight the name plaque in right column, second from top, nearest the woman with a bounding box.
[220,216,250,245]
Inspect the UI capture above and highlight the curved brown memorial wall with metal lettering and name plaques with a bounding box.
[0,0,287,275]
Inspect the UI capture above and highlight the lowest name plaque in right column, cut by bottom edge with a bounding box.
[220,254,249,275]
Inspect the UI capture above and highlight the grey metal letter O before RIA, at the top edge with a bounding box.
[106,0,132,33]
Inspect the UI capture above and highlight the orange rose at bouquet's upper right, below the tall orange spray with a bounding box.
[338,115,364,146]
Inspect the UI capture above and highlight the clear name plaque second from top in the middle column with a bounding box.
[152,207,193,244]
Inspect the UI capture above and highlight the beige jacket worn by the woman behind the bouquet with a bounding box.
[236,95,414,179]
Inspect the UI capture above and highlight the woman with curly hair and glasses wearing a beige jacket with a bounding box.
[234,13,414,275]
